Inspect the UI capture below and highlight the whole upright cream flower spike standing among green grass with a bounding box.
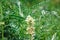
[25,15,35,40]
